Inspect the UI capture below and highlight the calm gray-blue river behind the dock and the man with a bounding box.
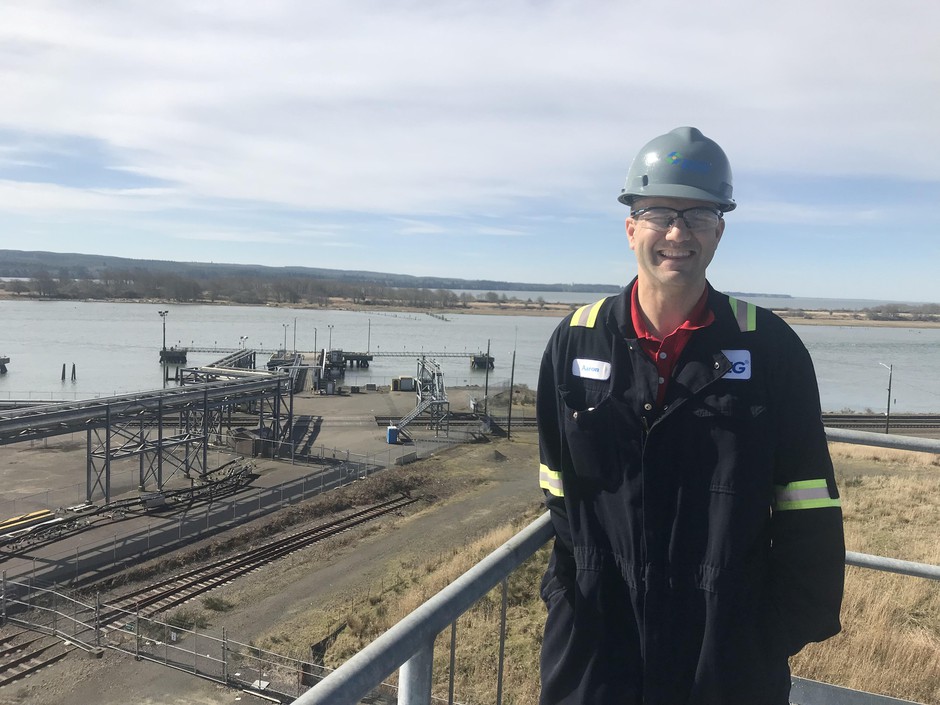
[0,292,940,413]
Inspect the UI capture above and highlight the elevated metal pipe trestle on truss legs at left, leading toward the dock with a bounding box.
[0,360,296,503]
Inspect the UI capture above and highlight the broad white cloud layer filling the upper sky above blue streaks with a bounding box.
[0,0,940,212]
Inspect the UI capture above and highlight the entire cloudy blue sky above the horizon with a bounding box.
[0,0,940,302]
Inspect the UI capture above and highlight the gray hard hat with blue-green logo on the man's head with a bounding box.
[617,127,737,212]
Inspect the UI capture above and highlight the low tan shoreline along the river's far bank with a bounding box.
[0,290,940,328]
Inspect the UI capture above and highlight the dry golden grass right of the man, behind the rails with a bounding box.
[791,444,940,705]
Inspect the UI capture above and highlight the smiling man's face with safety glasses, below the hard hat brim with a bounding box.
[627,198,725,292]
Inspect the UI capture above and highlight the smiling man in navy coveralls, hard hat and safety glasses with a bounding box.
[538,127,845,705]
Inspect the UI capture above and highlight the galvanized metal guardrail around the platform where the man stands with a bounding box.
[293,428,940,705]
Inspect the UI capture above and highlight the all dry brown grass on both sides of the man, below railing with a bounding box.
[282,444,940,705]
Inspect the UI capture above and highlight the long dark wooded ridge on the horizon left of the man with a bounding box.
[0,250,620,293]
